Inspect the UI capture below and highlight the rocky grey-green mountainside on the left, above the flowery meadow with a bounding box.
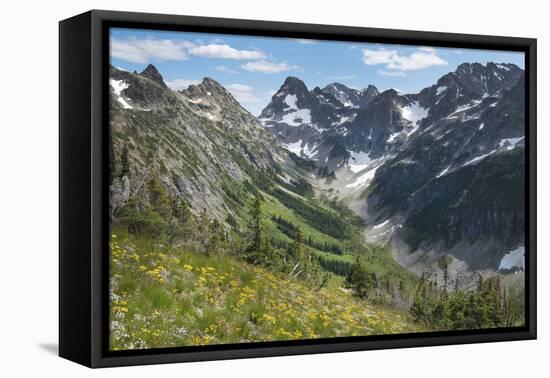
[110,65,412,280]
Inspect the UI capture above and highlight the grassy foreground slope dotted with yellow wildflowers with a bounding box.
[110,232,422,350]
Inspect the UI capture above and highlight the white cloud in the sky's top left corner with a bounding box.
[110,38,193,63]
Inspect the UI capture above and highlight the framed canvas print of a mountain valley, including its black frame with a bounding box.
[59,11,536,367]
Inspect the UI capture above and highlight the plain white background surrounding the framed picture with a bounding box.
[0,0,550,378]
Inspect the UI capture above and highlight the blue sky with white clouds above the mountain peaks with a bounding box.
[111,28,524,115]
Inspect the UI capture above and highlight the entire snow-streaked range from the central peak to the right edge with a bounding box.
[260,63,525,270]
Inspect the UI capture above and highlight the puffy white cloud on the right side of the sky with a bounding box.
[363,47,447,76]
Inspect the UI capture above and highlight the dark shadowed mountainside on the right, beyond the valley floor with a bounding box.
[367,66,525,269]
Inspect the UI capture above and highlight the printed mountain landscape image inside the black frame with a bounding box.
[108,28,526,350]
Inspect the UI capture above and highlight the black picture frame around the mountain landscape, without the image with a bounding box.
[59,10,537,368]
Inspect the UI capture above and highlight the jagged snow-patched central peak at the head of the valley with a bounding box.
[259,77,434,171]
